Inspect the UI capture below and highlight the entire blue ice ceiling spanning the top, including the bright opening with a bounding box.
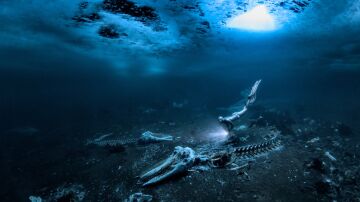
[0,0,360,75]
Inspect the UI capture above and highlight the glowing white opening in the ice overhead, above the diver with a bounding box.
[226,5,276,31]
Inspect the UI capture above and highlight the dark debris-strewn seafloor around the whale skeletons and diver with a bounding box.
[0,102,360,201]
